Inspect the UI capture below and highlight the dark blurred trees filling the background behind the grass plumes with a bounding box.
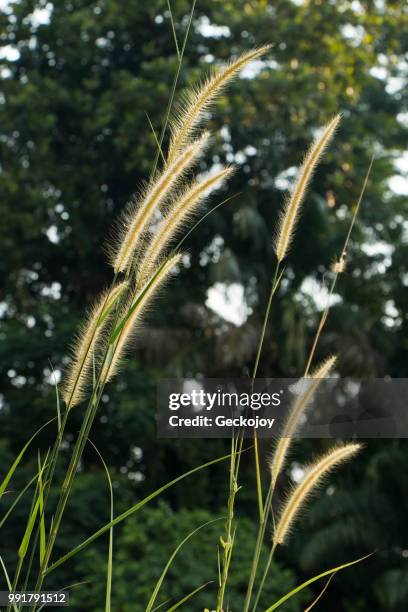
[0,0,408,612]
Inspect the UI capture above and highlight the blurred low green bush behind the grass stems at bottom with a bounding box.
[71,503,307,612]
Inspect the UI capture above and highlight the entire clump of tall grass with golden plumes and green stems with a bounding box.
[0,32,368,612]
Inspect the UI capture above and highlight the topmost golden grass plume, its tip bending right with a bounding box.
[167,45,271,163]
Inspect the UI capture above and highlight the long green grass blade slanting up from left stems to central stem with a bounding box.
[45,451,245,575]
